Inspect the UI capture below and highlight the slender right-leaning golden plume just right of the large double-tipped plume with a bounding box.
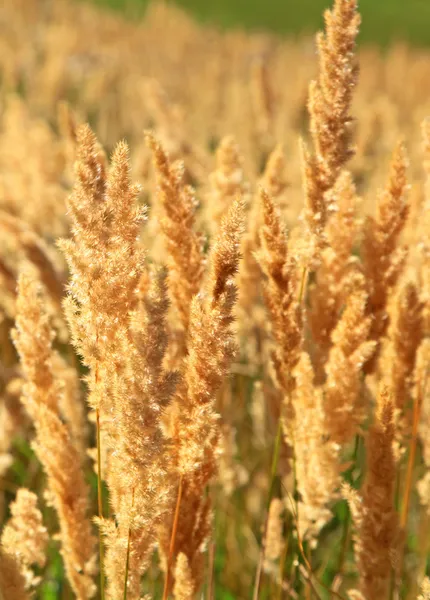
[178,195,244,474]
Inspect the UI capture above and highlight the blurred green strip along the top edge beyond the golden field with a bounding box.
[93,0,430,46]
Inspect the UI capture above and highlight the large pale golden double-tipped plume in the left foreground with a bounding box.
[60,125,144,409]
